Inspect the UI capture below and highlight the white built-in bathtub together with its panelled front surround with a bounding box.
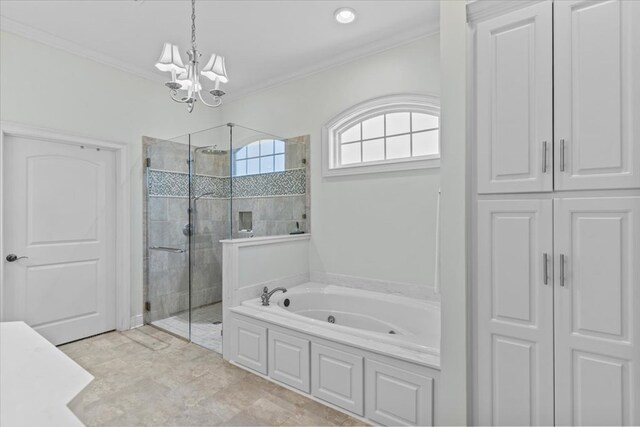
[225,284,440,425]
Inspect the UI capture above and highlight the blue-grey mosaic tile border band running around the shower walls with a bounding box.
[147,169,307,199]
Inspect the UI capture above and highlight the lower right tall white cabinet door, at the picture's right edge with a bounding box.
[554,197,640,425]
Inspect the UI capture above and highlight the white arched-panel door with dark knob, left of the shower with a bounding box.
[2,137,116,344]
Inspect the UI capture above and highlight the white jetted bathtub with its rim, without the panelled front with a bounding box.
[242,283,440,360]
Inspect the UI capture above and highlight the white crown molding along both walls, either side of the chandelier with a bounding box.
[0,15,440,102]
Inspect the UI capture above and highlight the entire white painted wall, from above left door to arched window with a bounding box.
[0,33,440,315]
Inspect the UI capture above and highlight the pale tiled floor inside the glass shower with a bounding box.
[151,302,222,353]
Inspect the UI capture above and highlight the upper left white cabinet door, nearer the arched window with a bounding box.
[476,2,553,193]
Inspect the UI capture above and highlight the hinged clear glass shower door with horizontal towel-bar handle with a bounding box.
[144,136,190,339]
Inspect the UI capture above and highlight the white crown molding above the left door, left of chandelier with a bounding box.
[0,16,166,83]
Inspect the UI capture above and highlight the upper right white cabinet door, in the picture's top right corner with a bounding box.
[554,0,640,190]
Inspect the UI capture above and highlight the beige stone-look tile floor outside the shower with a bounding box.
[60,326,363,426]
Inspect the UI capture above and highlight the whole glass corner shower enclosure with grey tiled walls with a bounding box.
[143,124,309,352]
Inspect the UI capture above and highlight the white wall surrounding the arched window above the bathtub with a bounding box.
[215,35,440,292]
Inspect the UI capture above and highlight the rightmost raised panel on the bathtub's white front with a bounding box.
[366,360,433,426]
